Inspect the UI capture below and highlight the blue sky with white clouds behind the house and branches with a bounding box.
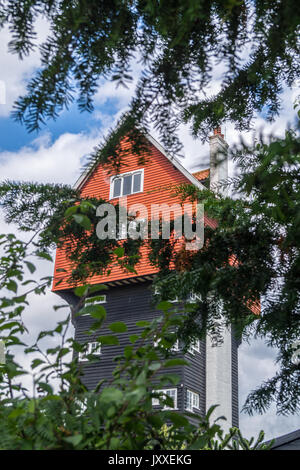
[0,21,300,439]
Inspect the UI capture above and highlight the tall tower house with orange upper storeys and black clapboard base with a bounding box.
[53,129,238,427]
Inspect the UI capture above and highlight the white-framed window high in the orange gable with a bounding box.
[109,169,144,199]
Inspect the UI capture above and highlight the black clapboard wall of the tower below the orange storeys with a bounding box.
[56,282,238,425]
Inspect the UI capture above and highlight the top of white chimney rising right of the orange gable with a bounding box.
[209,127,228,195]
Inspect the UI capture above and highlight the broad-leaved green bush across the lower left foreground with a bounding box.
[0,234,272,450]
